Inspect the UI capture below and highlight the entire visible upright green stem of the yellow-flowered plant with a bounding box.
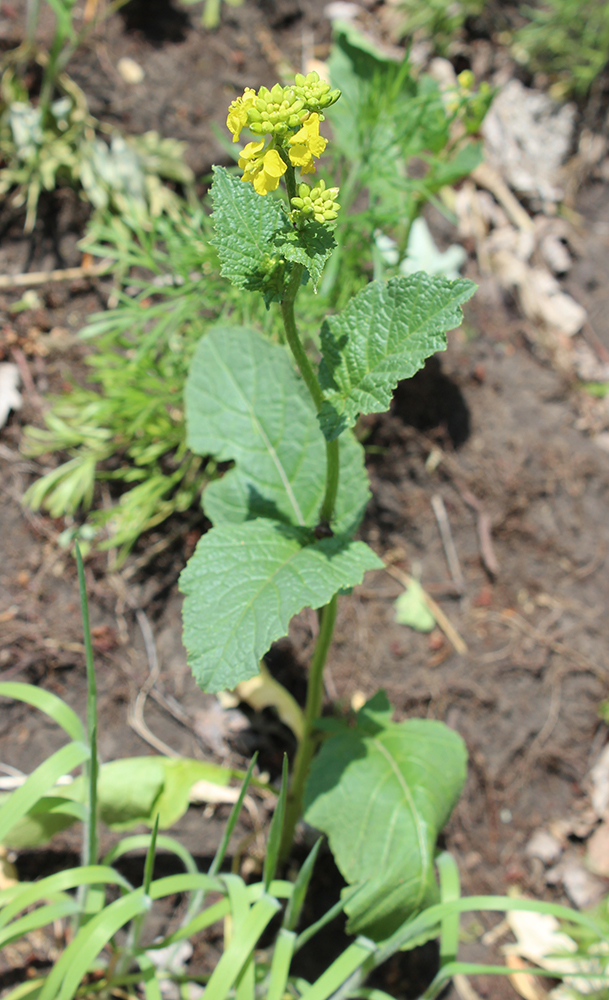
[280,256,340,858]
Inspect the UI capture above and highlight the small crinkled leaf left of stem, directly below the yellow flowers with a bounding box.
[211,167,291,305]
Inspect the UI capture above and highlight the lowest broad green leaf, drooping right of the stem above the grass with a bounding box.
[304,692,467,938]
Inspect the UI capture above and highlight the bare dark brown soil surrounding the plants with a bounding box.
[0,0,609,998]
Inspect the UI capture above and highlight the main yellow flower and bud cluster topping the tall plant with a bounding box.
[226,72,340,195]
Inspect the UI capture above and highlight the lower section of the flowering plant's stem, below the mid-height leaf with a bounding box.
[281,594,338,858]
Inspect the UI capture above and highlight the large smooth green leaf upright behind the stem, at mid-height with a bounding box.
[186,324,370,536]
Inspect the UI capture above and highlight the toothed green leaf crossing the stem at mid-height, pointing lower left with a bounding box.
[180,518,382,691]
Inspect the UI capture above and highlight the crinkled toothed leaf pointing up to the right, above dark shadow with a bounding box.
[319,272,476,441]
